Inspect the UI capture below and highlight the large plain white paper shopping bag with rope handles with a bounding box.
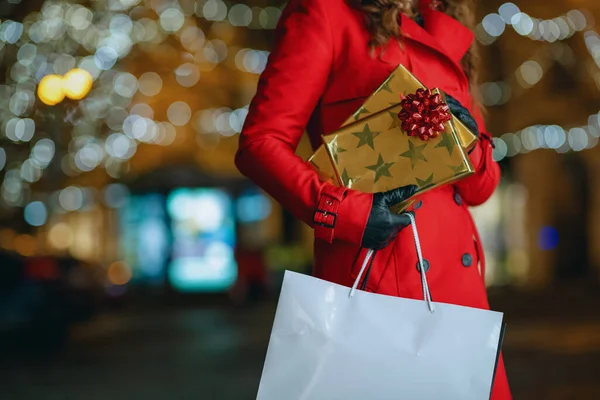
[257,215,502,400]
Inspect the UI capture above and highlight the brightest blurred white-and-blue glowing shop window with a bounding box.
[167,188,238,293]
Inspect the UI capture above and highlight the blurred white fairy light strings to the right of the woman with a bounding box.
[475,2,600,161]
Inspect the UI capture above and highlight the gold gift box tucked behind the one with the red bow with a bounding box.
[308,64,477,184]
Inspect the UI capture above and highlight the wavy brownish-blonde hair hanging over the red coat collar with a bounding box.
[348,0,479,94]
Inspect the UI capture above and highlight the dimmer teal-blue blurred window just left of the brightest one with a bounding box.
[121,194,169,284]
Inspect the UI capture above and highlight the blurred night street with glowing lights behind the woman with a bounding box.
[0,0,600,400]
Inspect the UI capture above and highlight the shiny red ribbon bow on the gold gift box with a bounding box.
[398,89,452,141]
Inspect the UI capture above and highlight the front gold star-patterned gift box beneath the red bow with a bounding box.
[323,91,475,212]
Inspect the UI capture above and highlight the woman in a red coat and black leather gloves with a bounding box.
[236,0,511,400]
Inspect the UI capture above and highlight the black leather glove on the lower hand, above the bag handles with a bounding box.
[362,185,418,250]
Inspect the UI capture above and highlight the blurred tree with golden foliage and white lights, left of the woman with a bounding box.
[0,0,281,225]
